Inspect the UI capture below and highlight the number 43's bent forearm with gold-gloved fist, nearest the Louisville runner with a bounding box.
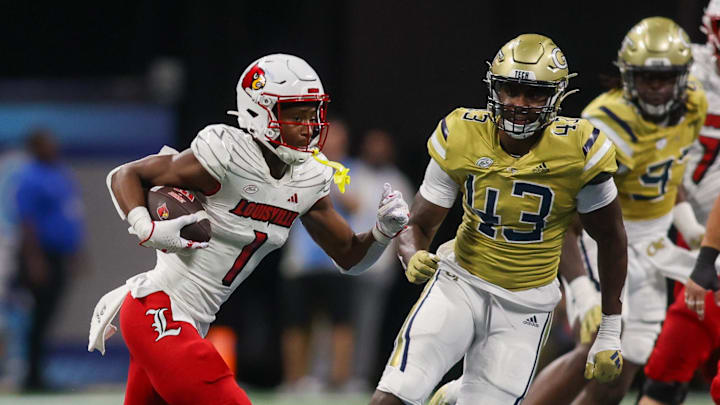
[397,192,450,284]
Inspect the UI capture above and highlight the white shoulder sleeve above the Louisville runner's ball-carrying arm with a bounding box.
[190,125,231,183]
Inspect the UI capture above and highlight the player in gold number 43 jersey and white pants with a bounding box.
[371,34,627,405]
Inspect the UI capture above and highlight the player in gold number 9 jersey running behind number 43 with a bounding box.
[504,17,707,405]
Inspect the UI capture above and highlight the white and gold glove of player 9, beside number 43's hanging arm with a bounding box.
[568,276,602,343]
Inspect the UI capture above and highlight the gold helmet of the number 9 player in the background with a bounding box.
[617,17,693,119]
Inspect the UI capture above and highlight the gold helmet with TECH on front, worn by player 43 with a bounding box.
[485,34,575,139]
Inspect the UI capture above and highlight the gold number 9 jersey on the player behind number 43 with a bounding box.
[582,77,707,220]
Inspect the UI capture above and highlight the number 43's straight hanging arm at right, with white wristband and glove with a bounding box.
[580,197,627,383]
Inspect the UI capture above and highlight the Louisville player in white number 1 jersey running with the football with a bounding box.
[88,54,408,405]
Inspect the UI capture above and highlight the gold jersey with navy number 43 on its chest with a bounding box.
[428,108,617,290]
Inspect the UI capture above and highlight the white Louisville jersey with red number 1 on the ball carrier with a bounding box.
[128,125,333,335]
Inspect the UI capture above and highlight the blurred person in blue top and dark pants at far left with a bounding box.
[17,130,84,391]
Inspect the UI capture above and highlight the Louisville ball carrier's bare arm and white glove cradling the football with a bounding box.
[109,149,219,252]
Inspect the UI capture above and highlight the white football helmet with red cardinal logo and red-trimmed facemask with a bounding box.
[228,54,330,165]
